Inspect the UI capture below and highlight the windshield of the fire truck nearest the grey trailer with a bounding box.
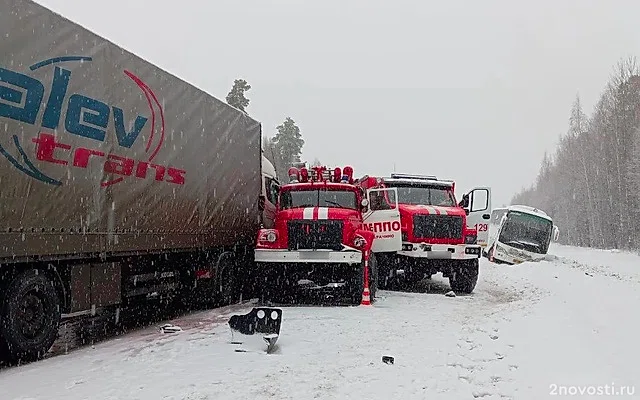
[280,189,358,210]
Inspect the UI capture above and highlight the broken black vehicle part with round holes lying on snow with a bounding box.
[229,307,282,354]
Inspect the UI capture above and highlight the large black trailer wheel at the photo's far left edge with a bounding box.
[0,270,61,361]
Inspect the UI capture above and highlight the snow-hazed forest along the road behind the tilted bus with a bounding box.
[511,57,640,249]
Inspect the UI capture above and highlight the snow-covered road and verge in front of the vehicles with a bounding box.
[0,246,640,400]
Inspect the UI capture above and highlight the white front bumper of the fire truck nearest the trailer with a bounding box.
[255,249,362,264]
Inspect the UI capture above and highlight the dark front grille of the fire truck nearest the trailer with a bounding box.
[287,220,343,251]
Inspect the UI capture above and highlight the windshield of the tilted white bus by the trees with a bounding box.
[498,211,553,254]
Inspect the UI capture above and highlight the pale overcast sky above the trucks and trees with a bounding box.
[37,0,640,206]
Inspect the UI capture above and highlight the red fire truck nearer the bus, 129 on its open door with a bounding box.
[359,174,491,293]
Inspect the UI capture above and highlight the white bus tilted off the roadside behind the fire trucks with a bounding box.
[484,205,559,265]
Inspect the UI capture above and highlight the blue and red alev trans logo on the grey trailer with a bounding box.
[0,56,186,187]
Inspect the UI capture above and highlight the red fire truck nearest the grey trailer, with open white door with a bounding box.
[255,166,402,304]
